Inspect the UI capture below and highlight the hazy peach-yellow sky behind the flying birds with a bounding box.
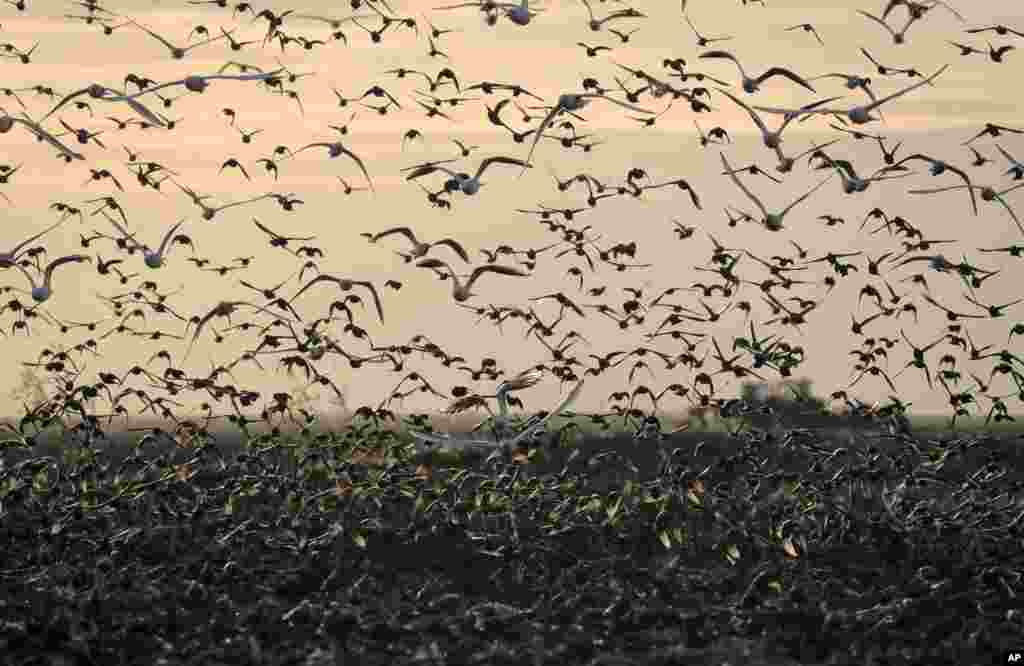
[0,0,1024,422]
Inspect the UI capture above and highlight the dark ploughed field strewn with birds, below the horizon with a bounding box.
[0,409,1024,664]
